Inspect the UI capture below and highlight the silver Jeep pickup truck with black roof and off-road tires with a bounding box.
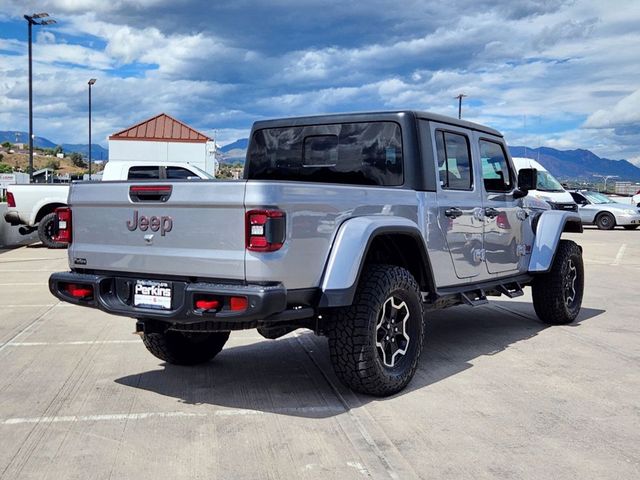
[49,111,584,396]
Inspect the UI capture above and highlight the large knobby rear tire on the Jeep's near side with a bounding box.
[326,265,425,396]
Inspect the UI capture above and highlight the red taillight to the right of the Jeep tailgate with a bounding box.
[246,210,286,252]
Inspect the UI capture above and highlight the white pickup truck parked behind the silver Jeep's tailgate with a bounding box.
[4,161,214,248]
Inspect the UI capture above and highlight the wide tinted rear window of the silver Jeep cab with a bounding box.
[247,122,403,186]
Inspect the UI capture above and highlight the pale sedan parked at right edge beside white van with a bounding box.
[570,190,640,230]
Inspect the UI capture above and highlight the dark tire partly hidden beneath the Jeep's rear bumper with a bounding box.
[142,330,229,365]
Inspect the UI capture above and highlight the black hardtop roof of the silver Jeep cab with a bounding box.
[253,110,502,137]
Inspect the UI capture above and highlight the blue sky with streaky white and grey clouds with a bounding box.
[0,0,640,165]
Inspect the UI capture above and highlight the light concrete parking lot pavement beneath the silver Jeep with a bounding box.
[0,229,640,479]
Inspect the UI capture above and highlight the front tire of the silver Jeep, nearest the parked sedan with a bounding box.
[532,240,584,325]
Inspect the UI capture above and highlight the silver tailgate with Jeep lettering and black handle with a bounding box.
[69,181,245,280]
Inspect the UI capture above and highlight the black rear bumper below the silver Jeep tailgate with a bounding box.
[49,272,314,329]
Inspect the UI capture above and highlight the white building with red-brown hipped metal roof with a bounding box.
[109,113,216,175]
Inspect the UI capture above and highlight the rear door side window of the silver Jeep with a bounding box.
[436,130,473,190]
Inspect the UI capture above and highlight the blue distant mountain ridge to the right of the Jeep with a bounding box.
[509,146,640,181]
